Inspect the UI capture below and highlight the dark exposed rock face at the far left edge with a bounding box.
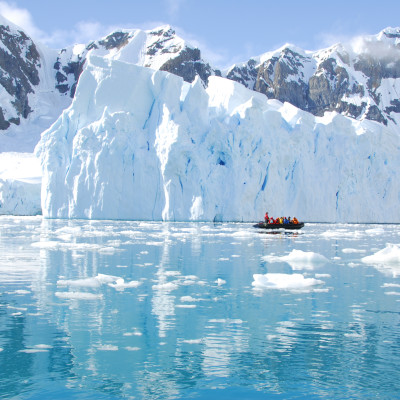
[0,25,40,130]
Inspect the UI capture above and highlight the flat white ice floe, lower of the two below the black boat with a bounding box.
[252,273,324,290]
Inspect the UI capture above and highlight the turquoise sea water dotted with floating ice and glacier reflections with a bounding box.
[0,217,400,400]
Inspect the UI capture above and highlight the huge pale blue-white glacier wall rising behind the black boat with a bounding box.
[36,56,400,222]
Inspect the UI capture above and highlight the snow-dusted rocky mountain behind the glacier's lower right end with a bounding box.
[224,28,400,125]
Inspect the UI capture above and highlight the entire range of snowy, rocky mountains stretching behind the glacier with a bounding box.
[0,18,400,152]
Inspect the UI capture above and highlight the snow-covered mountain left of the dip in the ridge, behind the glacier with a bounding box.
[0,16,221,153]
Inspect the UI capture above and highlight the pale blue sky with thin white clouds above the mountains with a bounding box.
[0,0,400,68]
